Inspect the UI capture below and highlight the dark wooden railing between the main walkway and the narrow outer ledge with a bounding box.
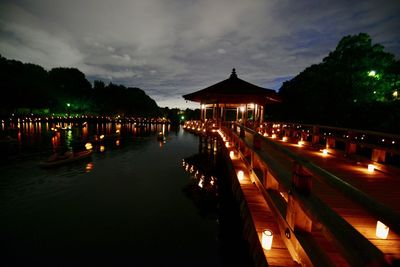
[224,123,400,266]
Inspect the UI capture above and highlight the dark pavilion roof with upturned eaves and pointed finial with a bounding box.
[183,69,280,105]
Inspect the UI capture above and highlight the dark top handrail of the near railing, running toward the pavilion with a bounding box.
[234,123,400,237]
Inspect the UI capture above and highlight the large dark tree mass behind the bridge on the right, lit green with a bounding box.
[272,33,400,134]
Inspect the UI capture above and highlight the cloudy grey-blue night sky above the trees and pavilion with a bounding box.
[0,0,400,108]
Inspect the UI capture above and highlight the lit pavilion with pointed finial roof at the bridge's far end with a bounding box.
[183,69,280,126]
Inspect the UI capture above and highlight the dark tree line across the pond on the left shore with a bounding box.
[0,55,160,116]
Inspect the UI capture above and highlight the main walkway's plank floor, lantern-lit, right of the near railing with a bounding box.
[264,141,400,259]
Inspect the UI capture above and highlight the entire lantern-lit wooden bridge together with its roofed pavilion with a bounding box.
[184,71,400,266]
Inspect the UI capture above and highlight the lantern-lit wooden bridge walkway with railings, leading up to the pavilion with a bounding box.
[184,121,400,266]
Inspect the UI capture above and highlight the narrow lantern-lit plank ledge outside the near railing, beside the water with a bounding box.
[228,159,297,266]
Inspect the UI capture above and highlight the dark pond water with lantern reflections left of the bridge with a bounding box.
[0,122,251,266]
